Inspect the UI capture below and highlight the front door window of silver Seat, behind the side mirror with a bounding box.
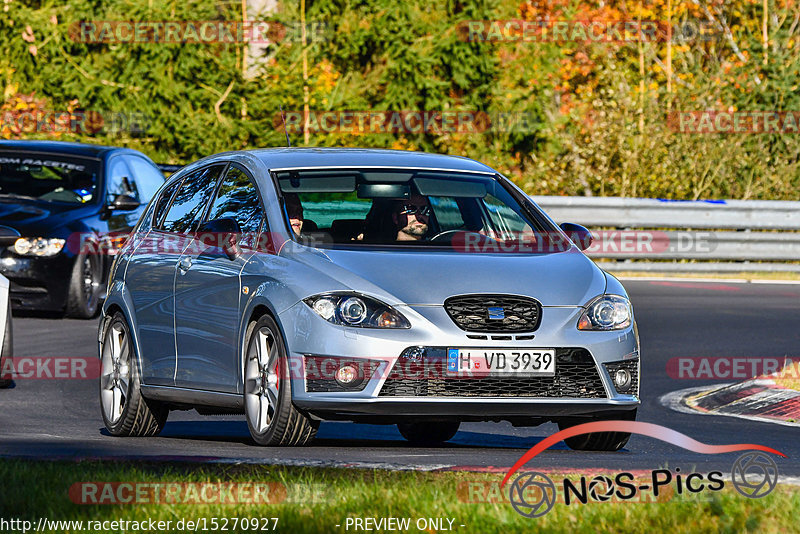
[208,167,263,234]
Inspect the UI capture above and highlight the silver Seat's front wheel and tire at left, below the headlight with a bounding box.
[244,315,319,446]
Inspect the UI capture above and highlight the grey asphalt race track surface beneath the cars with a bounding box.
[0,280,800,477]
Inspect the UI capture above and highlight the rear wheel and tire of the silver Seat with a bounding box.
[100,312,169,437]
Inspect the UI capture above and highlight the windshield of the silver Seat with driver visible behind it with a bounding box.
[275,169,558,252]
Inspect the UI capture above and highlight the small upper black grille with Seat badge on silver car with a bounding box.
[444,295,542,332]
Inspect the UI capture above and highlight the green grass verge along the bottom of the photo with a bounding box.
[0,459,800,533]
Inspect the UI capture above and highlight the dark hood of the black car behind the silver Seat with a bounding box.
[0,196,94,237]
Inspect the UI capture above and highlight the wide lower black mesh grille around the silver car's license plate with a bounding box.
[378,347,606,399]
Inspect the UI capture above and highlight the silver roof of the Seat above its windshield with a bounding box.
[253,148,497,174]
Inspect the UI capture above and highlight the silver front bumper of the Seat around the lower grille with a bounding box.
[280,303,640,420]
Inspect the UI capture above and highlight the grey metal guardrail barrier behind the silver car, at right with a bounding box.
[531,196,800,272]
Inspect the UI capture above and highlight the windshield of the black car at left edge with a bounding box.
[0,151,100,204]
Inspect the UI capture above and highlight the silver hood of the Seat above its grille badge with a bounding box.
[287,248,606,306]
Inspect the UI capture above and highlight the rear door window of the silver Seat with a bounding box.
[161,165,223,234]
